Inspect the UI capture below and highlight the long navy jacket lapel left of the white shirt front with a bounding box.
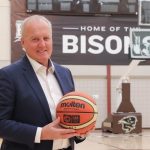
[23,57,52,120]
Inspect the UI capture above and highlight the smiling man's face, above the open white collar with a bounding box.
[21,20,52,67]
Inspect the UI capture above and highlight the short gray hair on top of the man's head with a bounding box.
[21,15,52,37]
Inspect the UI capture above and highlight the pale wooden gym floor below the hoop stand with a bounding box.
[0,129,150,150]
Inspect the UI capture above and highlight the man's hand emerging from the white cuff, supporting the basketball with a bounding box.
[41,118,79,140]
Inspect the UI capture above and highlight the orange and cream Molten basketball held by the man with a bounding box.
[56,91,98,134]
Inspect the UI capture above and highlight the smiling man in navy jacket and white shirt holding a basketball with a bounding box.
[0,15,85,150]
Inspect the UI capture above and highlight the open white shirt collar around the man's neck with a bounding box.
[26,54,55,73]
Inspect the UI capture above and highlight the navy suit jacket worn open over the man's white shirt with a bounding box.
[0,56,75,150]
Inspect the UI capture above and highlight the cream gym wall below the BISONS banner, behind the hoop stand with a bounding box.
[67,65,150,128]
